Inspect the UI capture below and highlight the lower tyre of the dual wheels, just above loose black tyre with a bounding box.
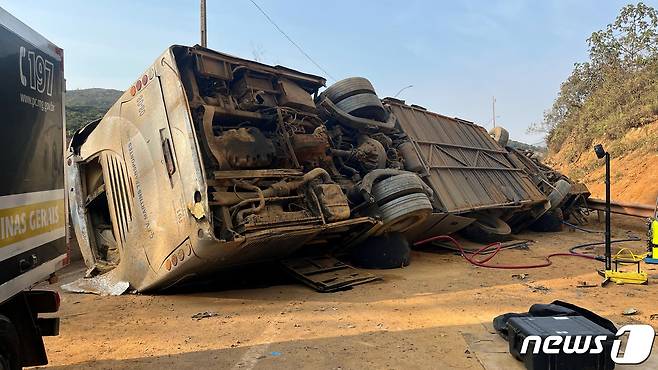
[379,193,432,233]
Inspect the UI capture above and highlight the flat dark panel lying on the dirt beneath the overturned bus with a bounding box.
[281,256,381,293]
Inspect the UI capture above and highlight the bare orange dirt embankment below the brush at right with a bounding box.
[546,121,658,205]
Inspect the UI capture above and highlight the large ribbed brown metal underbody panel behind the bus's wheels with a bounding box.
[385,99,545,213]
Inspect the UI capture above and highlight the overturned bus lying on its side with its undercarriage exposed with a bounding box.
[67,46,548,291]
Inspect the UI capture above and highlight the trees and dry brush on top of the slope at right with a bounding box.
[530,2,658,160]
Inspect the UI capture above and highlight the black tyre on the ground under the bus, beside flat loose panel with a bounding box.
[351,233,411,269]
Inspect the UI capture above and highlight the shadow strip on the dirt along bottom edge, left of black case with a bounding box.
[39,325,486,370]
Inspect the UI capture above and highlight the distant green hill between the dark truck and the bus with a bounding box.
[66,88,123,137]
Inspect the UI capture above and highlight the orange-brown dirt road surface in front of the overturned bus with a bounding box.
[34,212,658,369]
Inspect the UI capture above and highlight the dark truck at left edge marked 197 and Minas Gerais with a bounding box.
[0,8,68,369]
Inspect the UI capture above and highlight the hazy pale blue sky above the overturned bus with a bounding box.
[0,0,658,144]
